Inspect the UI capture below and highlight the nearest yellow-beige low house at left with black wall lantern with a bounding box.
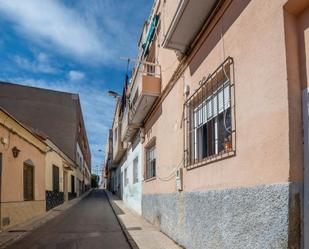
[0,109,47,230]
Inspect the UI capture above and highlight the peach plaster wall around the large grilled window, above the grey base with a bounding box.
[143,0,292,194]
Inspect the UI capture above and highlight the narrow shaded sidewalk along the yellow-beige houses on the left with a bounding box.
[0,190,91,249]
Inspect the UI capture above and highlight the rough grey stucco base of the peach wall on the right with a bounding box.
[142,183,301,249]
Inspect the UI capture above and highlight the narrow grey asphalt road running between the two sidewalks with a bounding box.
[7,190,130,249]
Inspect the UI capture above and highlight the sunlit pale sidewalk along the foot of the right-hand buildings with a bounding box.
[105,191,182,249]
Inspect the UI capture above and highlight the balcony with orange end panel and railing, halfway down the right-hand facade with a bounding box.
[121,62,161,141]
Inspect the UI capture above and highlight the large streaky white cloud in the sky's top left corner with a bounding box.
[0,0,106,63]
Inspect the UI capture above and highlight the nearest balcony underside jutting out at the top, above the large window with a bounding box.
[163,0,220,53]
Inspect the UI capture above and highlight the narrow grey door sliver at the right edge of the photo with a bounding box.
[302,88,309,249]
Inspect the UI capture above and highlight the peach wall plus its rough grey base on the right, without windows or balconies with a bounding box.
[142,0,308,248]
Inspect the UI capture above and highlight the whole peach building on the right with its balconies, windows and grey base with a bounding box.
[109,0,309,249]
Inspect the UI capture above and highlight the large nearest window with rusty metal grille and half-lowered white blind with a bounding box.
[185,58,235,166]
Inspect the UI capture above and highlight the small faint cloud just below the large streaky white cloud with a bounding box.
[13,53,58,73]
